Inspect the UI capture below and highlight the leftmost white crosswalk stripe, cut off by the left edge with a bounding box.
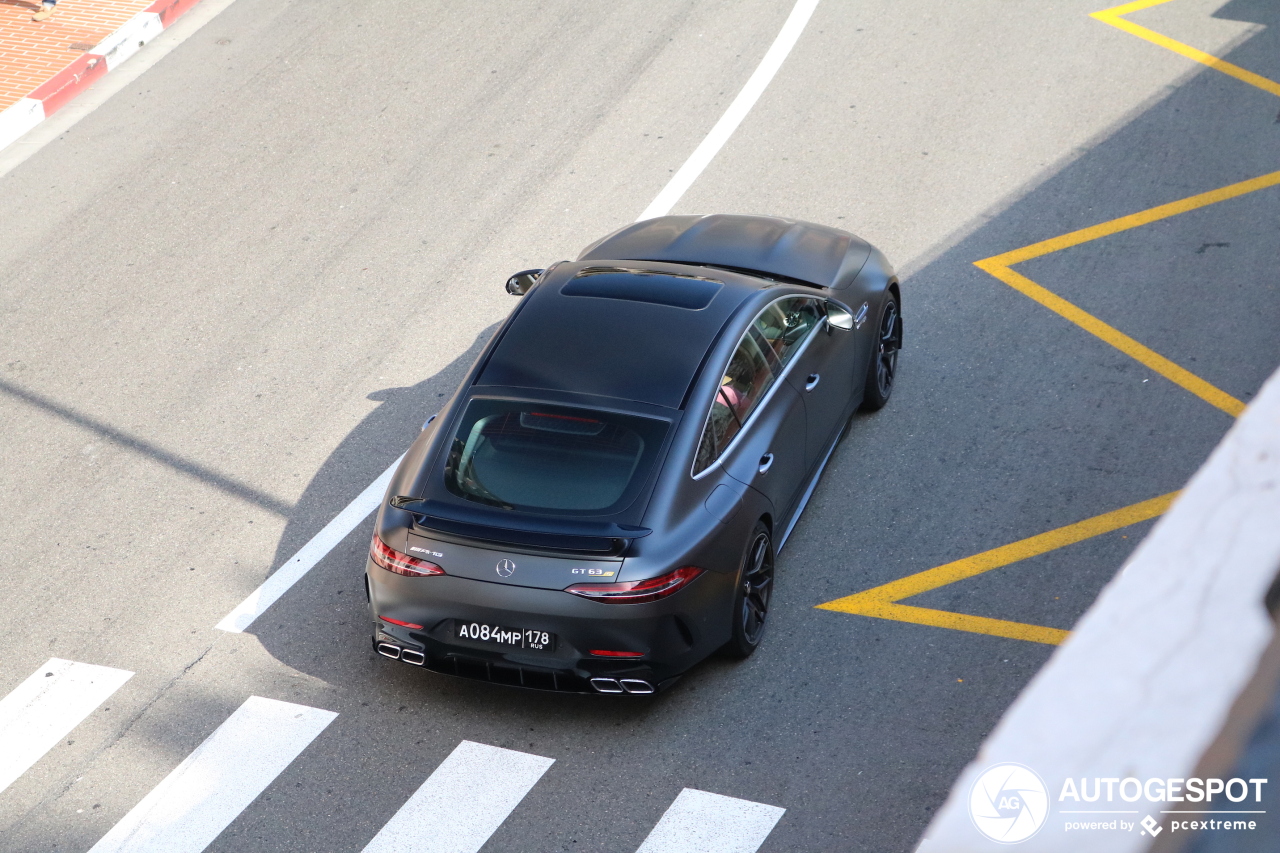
[0,657,133,790]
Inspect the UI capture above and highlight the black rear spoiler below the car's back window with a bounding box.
[389,494,653,556]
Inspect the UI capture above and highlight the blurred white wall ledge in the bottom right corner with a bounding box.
[918,363,1280,853]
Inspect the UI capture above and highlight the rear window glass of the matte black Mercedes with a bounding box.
[444,400,667,515]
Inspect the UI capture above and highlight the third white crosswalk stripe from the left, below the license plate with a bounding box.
[364,740,556,853]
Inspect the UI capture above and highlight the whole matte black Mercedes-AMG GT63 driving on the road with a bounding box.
[366,215,902,693]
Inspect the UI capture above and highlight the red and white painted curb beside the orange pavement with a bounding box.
[0,0,198,149]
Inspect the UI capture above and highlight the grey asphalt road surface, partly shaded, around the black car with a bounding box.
[0,0,1280,853]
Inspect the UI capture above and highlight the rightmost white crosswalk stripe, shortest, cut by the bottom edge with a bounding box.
[636,788,786,853]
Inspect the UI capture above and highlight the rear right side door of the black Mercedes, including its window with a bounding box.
[695,318,808,520]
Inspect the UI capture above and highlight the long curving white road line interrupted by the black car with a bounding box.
[215,0,818,633]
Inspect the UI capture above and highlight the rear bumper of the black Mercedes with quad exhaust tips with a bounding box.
[366,561,733,693]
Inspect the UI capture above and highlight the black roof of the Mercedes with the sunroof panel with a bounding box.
[475,260,772,409]
